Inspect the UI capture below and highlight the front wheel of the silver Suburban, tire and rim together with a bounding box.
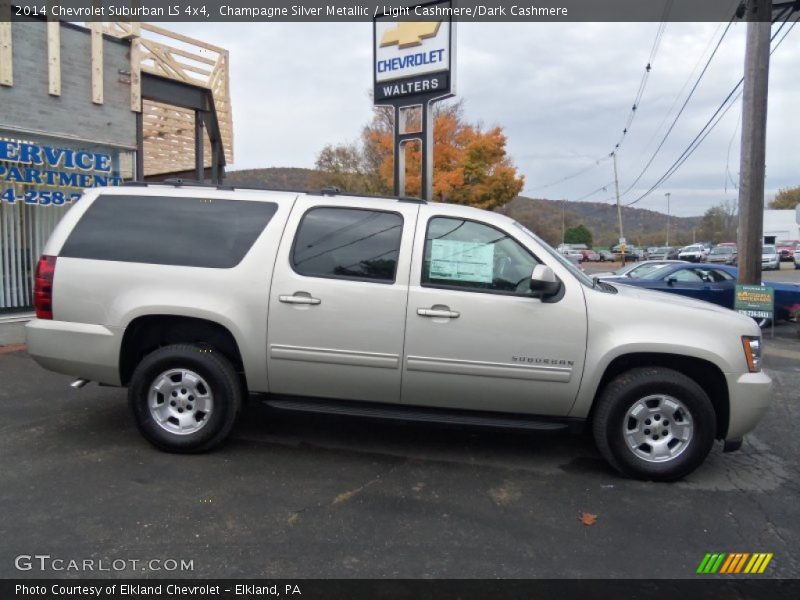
[593,367,716,481]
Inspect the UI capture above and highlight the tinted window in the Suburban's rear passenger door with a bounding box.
[291,207,403,283]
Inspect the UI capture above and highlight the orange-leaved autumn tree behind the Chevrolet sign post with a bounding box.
[317,102,524,209]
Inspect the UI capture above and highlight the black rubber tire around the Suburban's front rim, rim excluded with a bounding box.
[592,367,716,481]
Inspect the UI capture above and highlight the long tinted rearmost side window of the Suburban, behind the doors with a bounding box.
[61,195,278,269]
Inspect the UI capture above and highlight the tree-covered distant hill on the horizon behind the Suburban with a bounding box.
[225,167,700,246]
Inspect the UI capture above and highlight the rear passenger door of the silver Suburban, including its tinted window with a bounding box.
[267,196,419,402]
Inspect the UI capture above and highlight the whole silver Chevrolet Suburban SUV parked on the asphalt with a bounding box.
[27,184,771,480]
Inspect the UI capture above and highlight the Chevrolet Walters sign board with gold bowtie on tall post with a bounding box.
[373,0,455,104]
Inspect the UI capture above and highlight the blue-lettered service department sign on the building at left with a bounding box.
[0,139,122,206]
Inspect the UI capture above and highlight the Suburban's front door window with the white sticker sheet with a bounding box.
[422,217,539,296]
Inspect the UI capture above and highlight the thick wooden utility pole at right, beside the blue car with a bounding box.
[737,0,772,285]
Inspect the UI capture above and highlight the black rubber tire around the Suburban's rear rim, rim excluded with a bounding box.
[128,344,244,453]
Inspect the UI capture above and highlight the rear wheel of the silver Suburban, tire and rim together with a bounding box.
[128,344,243,452]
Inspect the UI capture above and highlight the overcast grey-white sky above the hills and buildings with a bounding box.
[167,23,800,215]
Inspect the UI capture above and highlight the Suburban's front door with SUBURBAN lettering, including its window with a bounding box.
[402,205,586,415]
